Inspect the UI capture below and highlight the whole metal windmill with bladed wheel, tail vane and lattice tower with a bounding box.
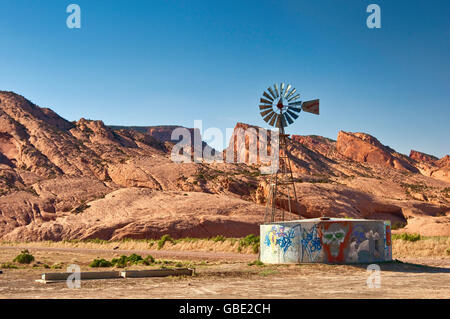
[259,83,319,222]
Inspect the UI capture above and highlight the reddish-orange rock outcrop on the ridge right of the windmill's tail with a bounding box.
[336,131,419,173]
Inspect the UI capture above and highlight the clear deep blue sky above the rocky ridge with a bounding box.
[0,0,450,157]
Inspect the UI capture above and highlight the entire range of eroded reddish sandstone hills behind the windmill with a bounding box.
[0,91,450,240]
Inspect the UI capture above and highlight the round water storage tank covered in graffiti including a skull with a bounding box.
[261,220,392,263]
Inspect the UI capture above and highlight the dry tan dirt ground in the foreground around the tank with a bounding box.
[0,246,450,299]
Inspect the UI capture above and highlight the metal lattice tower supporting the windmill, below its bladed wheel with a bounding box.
[264,128,297,223]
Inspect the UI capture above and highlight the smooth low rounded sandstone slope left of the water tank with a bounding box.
[4,188,270,240]
